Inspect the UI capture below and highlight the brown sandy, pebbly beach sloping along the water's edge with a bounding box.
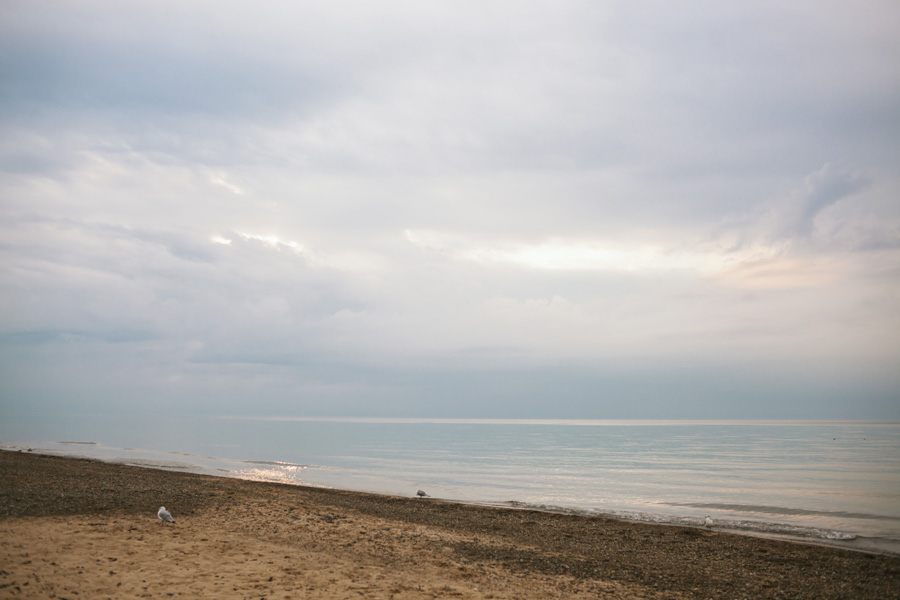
[0,452,900,600]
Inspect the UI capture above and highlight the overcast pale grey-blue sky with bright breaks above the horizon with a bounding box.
[0,0,900,419]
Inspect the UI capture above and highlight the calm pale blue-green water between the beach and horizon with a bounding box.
[0,415,900,553]
